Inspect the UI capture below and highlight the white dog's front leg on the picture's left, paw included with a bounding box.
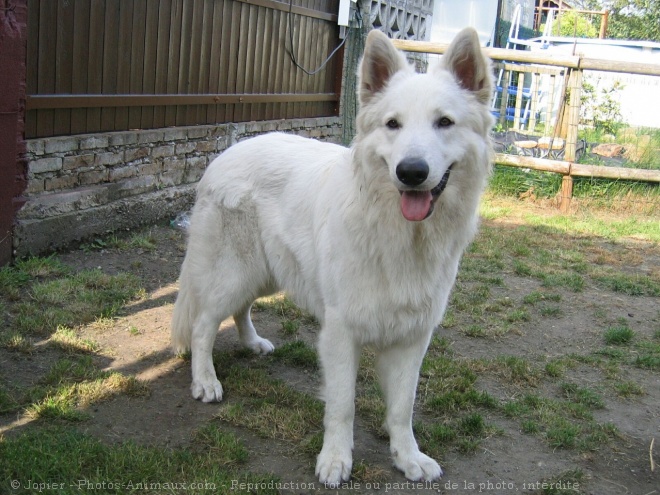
[316,317,360,487]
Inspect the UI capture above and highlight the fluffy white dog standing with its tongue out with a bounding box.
[172,28,492,486]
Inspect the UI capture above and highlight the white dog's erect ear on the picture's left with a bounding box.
[359,29,409,104]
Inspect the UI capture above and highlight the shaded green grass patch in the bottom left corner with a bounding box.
[0,426,277,495]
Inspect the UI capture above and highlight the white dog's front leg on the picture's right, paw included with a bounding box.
[376,339,442,481]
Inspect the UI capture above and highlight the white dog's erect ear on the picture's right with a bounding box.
[442,28,493,103]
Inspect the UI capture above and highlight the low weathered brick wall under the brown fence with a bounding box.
[14,117,341,256]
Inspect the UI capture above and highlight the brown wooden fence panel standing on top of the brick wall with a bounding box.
[26,0,342,138]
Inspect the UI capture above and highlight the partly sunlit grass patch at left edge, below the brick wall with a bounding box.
[0,256,148,422]
